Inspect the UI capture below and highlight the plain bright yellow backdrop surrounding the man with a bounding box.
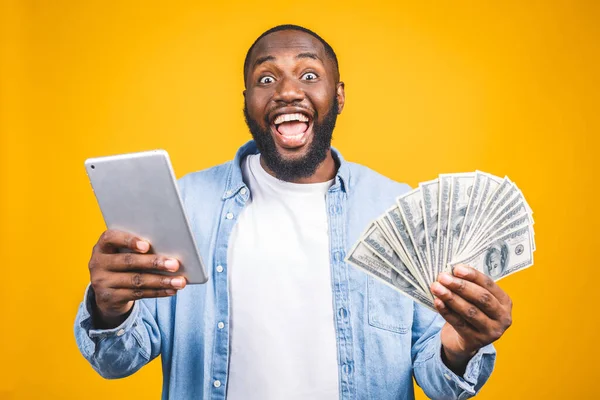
[0,0,600,399]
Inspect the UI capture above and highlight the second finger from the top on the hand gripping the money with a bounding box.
[438,272,503,319]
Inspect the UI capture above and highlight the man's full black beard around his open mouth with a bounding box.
[244,97,338,182]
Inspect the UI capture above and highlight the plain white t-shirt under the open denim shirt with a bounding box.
[227,155,339,400]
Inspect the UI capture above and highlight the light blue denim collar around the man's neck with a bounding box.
[223,140,350,200]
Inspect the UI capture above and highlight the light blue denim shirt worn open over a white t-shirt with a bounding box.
[75,141,495,400]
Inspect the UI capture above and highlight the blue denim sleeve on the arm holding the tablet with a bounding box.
[74,285,161,379]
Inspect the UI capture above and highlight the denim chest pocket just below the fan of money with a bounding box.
[367,276,413,334]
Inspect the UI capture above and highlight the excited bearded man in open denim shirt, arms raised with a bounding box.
[75,25,511,400]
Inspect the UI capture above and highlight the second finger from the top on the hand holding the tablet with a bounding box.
[99,253,179,272]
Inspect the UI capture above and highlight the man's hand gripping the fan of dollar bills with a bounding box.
[431,265,512,376]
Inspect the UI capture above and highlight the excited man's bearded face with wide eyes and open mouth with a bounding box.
[244,30,344,181]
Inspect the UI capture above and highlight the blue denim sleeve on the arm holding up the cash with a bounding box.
[411,304,496,400]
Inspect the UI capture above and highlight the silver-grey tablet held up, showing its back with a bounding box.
[85,150,208,284]
